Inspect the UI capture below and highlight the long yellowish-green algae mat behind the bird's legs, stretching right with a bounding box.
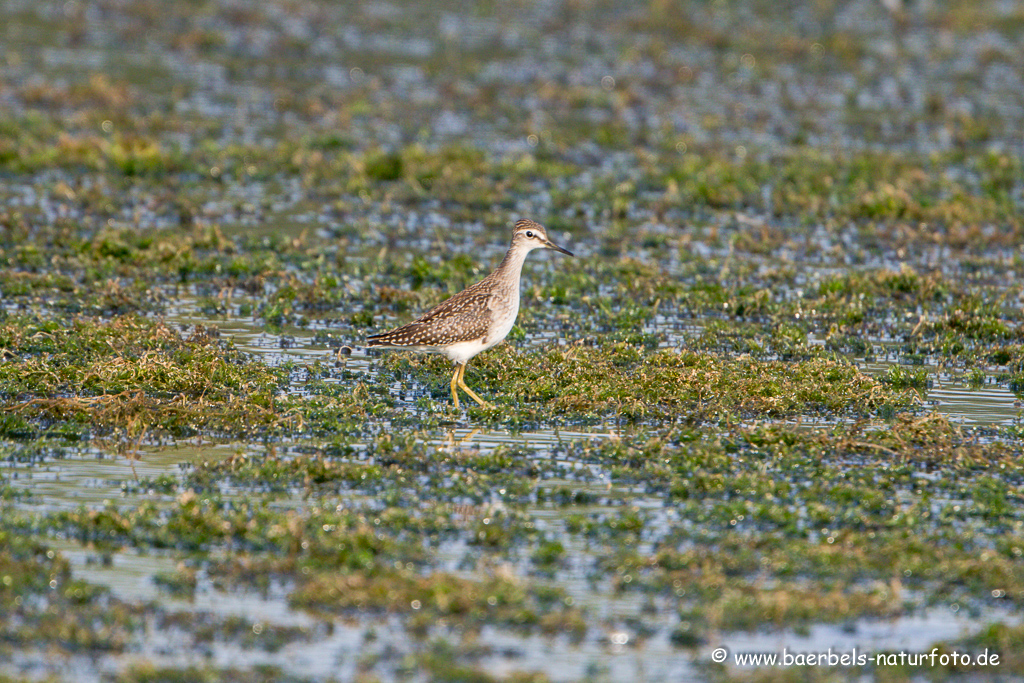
[374,343,916,420]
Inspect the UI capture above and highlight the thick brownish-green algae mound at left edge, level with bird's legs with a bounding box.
[0,316,287,439]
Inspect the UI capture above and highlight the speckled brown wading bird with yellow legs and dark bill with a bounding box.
[367,218,572,408]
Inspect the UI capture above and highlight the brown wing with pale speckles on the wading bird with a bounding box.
[367,283,493,346]
